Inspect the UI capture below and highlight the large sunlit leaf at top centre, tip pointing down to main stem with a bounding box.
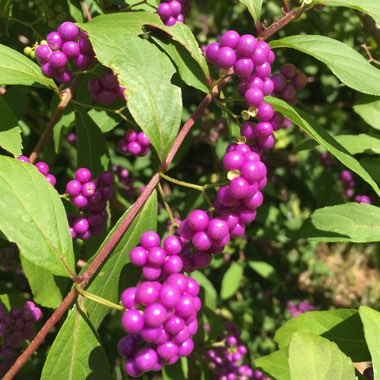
[78,12,182,161]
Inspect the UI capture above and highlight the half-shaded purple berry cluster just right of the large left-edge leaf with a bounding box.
[66,168,114,240]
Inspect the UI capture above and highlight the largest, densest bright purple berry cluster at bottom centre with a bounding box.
[118,262,201,377]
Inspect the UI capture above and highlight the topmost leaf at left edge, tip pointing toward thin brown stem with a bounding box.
[0,44,58,91]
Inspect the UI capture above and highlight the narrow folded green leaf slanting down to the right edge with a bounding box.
[266,96,380,195]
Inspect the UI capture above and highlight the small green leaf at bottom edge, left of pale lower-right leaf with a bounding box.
[255,348,291,380]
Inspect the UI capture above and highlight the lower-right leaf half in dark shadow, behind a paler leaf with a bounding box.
[274,309,370,362]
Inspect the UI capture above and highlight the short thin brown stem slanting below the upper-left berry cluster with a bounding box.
[29,75,81,164]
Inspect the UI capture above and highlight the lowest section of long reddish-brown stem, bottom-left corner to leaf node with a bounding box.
[2,289,78,380]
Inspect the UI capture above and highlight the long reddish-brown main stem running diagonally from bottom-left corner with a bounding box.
[4,73,232,380]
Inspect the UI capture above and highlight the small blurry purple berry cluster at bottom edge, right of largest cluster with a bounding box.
[205,325,256,380]
